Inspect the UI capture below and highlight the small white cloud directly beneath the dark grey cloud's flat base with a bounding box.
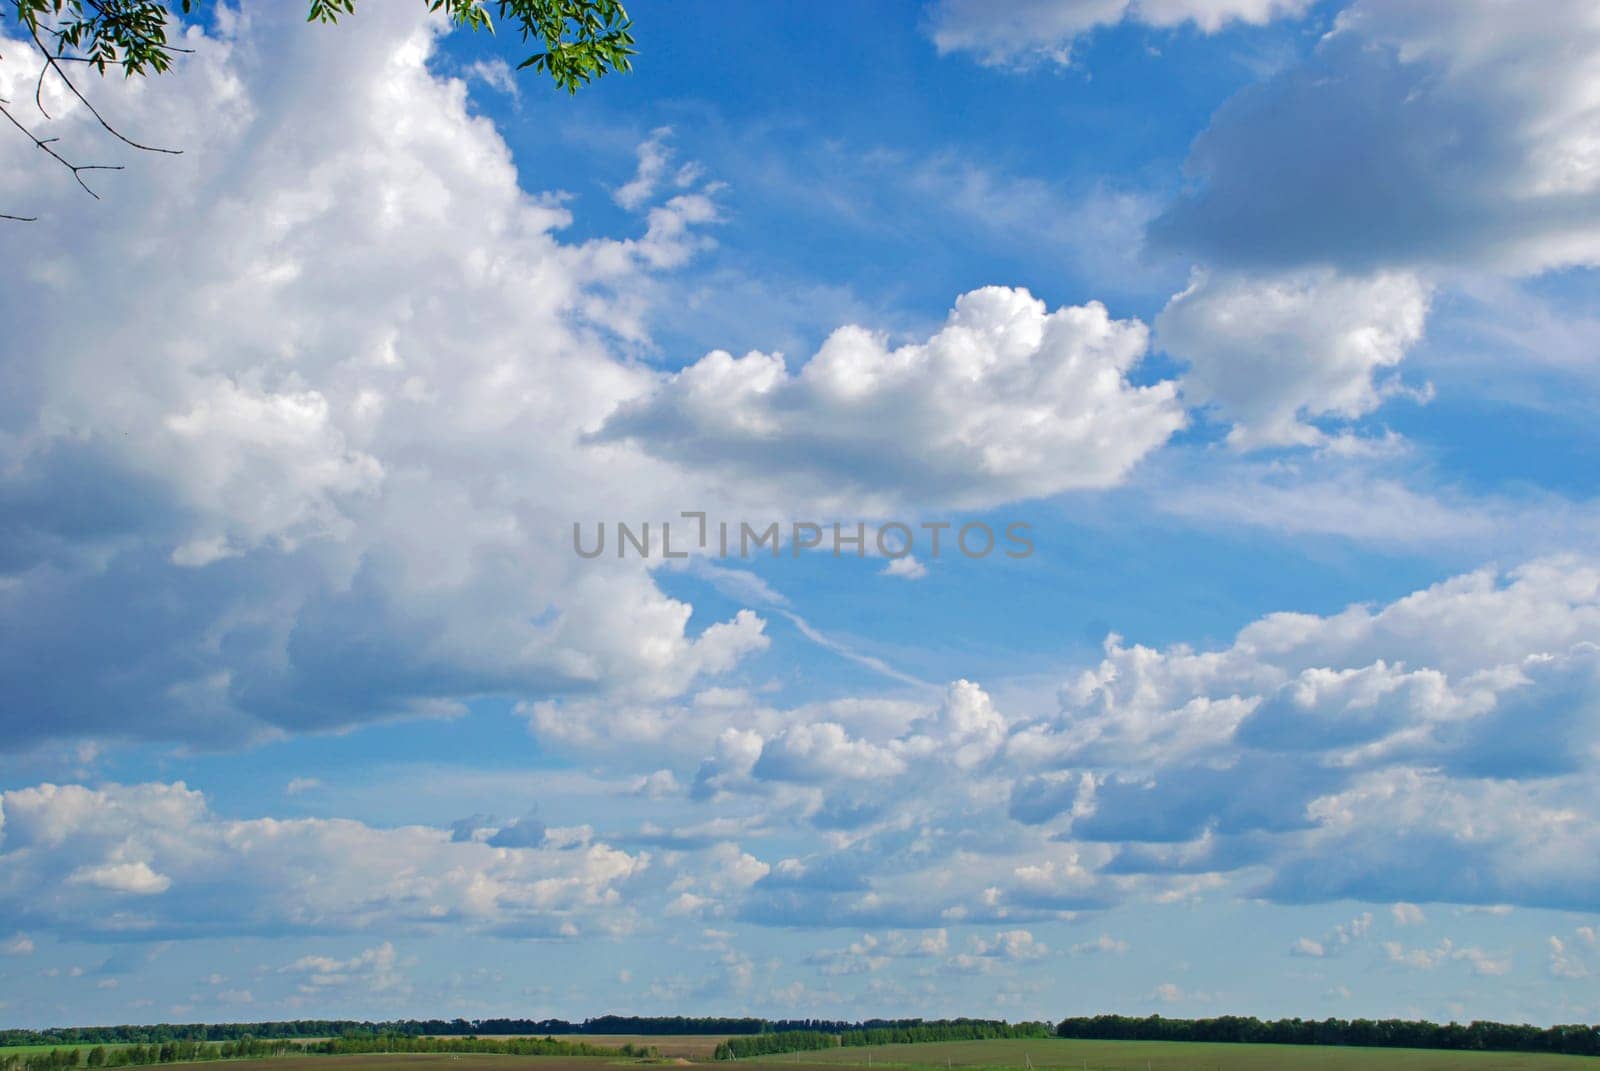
[1155,271,1427,447]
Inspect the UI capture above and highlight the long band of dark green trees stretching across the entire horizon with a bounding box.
[0,1015,1600,1071]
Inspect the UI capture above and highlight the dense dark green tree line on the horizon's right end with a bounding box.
[1056,1015,1600,1057]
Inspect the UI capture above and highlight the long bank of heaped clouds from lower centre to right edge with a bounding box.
[536,557,1600,928]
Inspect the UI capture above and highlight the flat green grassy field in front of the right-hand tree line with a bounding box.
[744,1037,1600,1071]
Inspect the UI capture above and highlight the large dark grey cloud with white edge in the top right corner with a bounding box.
[1149,0,1600,274]
